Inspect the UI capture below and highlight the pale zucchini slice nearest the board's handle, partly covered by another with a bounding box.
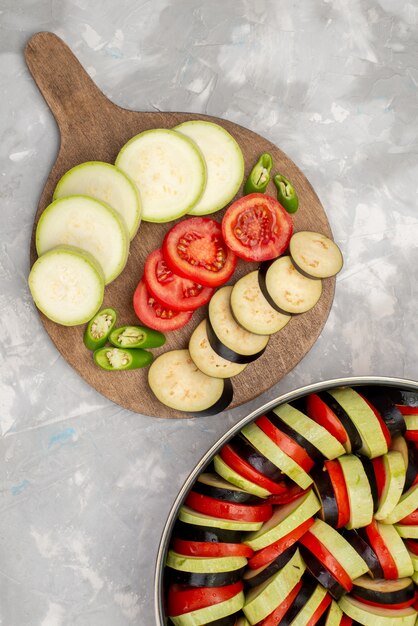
[53,161,141,239]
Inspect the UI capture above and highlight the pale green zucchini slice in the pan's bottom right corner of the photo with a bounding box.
[339,596,417,626]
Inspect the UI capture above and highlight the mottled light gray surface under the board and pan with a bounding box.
[0,0,418,626]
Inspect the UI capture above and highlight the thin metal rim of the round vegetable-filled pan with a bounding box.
[154,376,418,626]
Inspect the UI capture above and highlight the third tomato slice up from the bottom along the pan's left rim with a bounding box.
[186,491,273,522]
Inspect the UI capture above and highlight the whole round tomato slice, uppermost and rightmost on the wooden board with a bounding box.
[222,193,293,261]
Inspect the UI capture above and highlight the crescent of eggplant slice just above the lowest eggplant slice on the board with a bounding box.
[189,320,247,378]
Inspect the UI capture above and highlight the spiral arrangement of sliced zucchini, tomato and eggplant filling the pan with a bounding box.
[165,386,418,626]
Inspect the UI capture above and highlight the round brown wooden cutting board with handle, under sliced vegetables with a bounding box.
[25,32,335,418]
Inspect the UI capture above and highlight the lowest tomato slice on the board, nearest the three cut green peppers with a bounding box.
[133,280,193,333]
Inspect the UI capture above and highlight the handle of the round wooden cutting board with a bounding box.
[25,32,119,142]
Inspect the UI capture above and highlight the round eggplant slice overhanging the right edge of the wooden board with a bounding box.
[289,230,343,278]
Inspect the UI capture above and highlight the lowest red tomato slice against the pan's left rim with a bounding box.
[167,581,244,617]
